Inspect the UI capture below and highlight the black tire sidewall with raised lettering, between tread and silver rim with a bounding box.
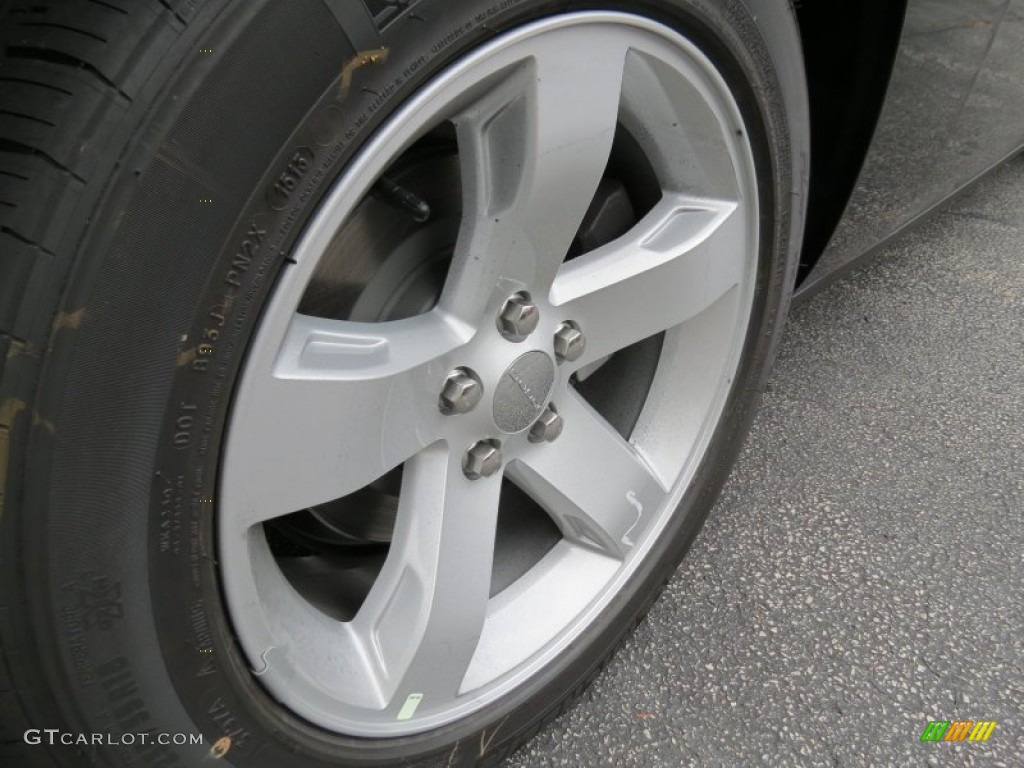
[26,0,795,768]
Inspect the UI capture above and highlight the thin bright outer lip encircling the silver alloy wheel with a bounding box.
[217,11,760,736]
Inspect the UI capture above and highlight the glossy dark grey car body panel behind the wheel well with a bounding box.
[799,0,1024,297]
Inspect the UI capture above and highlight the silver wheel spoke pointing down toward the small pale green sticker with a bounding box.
[352,443,502,717]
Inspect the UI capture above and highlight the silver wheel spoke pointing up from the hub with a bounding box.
[441,30,628,322]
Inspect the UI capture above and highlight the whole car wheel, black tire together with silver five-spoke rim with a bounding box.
[0,0,807,768]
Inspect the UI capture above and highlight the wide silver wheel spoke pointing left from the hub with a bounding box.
[223,312,465,529]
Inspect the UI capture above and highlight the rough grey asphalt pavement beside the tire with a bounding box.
[509,158,1024,768]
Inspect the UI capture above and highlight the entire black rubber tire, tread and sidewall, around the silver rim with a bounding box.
[0,0,808,768]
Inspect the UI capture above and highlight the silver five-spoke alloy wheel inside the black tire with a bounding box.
[217,12,759,736]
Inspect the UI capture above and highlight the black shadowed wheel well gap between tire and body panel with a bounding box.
[795,0,906,281]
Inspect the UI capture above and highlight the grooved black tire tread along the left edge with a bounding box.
[0,0,204,768]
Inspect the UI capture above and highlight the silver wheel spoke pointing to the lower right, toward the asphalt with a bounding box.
[509,393,666,557]
